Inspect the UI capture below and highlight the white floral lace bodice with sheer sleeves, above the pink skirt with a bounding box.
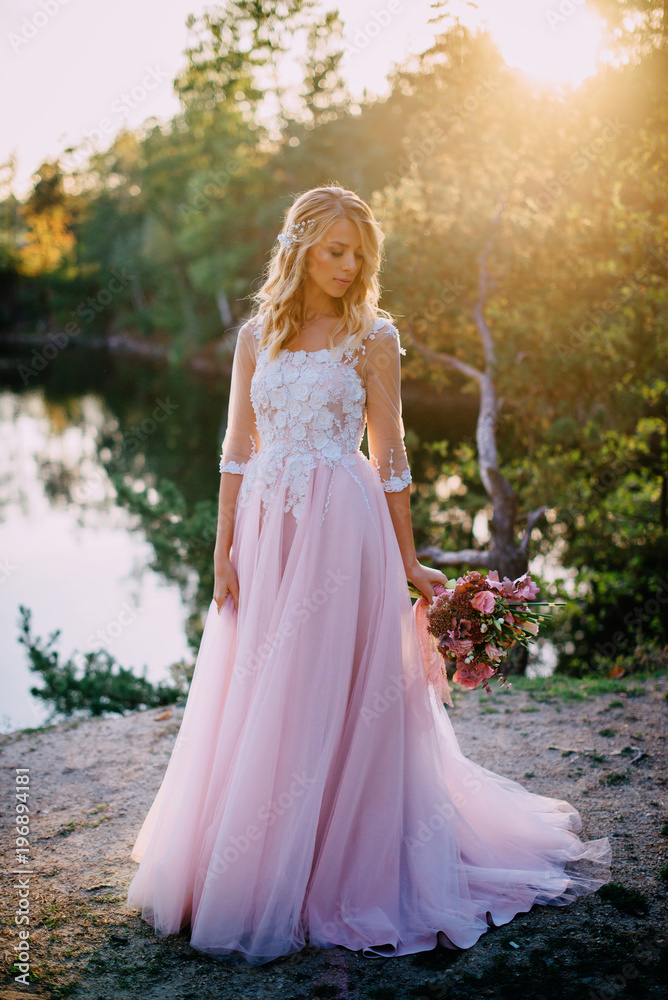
[220,319,411,518]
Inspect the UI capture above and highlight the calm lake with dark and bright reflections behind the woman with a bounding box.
[0,336,475,732]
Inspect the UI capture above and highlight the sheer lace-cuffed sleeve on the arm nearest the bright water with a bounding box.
[219,320,260,474]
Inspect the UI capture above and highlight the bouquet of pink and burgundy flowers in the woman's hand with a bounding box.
[423,570,548,705]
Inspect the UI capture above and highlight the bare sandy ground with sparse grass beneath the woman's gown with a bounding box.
[0,678,668,1000]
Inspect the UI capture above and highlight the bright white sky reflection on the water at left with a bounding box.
[0,387,192,732]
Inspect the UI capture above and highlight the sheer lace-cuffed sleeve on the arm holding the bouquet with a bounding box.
[364,323,412,493]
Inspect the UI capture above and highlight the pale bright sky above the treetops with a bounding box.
[0,0,600,198]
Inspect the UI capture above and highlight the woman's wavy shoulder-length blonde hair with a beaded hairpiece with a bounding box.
[250,185,392,361]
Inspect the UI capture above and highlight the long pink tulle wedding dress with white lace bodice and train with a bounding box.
[127,319,611,965]
